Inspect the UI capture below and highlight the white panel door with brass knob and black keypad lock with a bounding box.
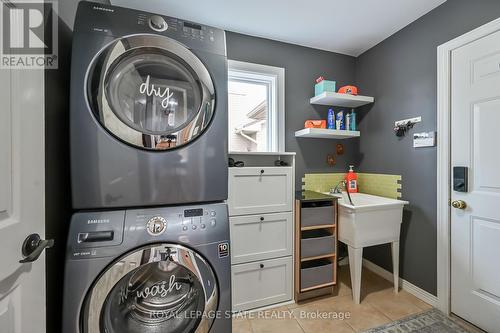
[451,28,500,333]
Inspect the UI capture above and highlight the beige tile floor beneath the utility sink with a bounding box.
[233,266,477,333]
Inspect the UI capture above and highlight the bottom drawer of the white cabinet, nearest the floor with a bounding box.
[231,257,293,311]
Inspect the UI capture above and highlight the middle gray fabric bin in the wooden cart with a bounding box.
[300,230,335,258]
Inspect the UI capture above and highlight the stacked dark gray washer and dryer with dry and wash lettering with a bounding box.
[63,1,231,333]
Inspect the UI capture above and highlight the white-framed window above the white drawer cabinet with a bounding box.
[228,60,285,152]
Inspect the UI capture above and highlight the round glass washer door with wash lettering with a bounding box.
[82,244,218,333]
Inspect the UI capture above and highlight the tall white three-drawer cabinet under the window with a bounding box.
[228,153,295,311]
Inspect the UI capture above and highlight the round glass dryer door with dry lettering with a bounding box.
[87,35,215,150]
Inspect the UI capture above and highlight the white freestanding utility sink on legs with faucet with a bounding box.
[325,193,408,304]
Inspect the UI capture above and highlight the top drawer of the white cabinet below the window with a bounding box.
[228,167,293,216]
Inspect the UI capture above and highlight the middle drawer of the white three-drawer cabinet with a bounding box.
[229,213,293,264]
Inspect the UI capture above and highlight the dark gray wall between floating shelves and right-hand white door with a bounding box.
[356,0,500,294]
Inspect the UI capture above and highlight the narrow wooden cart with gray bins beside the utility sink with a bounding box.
[294,191,337,302]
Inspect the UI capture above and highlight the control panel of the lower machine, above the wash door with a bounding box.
[68,203,229,260]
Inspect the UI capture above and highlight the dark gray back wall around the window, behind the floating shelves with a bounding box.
[227,32,359,189]
